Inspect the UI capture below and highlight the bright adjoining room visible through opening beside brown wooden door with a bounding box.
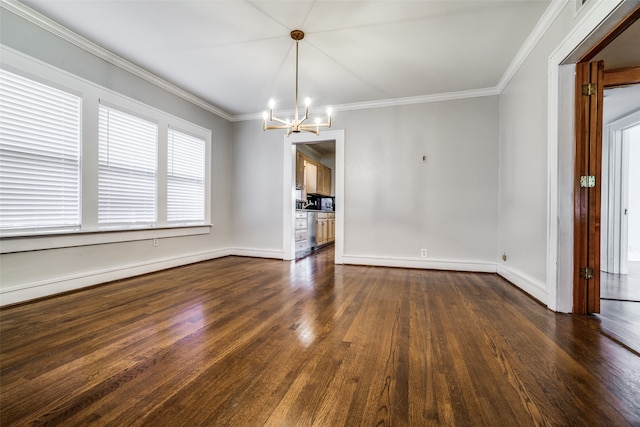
[598,108,640,353]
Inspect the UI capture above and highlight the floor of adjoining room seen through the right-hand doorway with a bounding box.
[596,262,640,354]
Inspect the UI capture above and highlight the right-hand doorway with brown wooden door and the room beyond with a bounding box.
[573,7,640,353]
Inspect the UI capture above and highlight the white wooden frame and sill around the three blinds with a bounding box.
[0,45,213,254]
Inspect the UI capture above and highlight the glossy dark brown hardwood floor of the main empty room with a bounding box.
[0,248,640,426]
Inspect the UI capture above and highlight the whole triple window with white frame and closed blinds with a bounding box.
[0,49,211,254]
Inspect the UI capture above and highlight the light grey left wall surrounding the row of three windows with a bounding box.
[0,9,232,304]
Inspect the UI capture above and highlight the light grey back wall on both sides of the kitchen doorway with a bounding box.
[233,97,498,271]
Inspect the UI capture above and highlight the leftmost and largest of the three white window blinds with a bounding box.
[0,69,82,231]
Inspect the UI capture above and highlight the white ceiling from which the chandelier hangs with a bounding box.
[18,0,550,116]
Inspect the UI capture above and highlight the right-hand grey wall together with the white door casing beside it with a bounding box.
[498,1,634,311]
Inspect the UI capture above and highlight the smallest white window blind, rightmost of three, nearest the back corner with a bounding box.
[167,129,205,222]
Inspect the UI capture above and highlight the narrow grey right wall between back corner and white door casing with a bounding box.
[497,5,573,303]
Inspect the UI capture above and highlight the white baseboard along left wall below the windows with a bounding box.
[0,249,231,306]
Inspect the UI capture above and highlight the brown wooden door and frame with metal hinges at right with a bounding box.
[572,7,640,314]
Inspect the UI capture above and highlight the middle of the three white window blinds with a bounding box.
[98,104,158,226]
